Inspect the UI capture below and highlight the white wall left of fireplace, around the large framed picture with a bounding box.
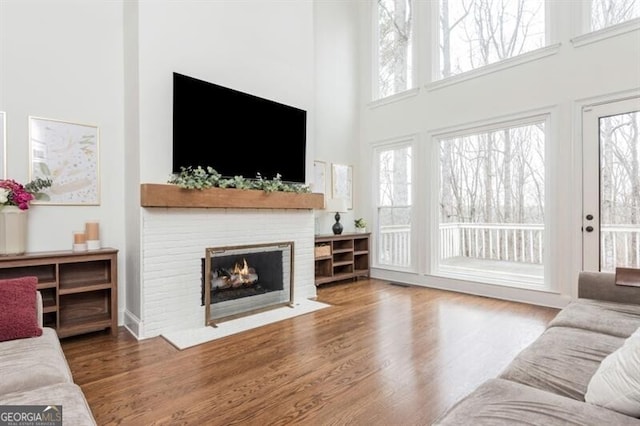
[0,0,125,318]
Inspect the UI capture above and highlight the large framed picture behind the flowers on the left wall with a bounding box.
[29,117,100,206]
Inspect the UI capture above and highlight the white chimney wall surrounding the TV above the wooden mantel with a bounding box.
[138,0,314,182]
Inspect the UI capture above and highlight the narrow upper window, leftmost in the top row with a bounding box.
[374,0,413,99]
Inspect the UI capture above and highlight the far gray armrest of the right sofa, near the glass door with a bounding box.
[578,271,640,305]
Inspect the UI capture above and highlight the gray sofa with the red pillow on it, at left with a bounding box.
[0,294,96,426]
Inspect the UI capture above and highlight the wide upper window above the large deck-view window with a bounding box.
[437,0,546,78]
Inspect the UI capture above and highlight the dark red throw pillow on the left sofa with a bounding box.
[0,277,42,342]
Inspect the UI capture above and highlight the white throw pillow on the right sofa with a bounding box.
[584,337,640,417]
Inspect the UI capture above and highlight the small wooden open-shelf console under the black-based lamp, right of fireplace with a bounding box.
[315,233,371,286]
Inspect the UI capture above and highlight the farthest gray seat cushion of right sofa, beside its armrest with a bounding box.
[549,299,640,337]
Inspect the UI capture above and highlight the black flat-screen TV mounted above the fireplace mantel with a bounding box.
[173,73,307,183]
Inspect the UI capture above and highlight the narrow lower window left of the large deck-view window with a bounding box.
[377,144,412,267]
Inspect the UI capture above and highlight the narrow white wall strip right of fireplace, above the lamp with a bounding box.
[313,0,368,234]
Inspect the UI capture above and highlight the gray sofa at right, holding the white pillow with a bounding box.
[434,272,640,426]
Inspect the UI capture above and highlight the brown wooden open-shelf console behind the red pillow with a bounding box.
[0,248,118,337]
